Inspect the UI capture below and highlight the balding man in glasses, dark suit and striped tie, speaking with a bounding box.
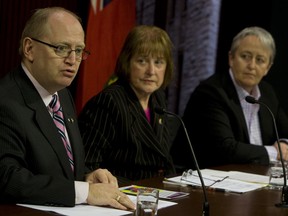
[0,7,134,209]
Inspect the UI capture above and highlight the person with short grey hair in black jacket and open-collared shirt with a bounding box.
[174,27,288,168]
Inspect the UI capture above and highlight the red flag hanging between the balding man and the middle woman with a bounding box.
[75,0,136,113]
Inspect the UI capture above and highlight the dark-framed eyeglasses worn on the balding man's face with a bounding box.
[31,38,90,61]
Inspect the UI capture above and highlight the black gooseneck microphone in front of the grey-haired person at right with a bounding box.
[245,96,288,208]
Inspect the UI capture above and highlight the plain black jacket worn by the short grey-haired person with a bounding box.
[173,73,288,168]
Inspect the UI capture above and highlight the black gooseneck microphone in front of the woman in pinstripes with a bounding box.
[154,107,210,216]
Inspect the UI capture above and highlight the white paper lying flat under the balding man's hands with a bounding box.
[18,195,177,216]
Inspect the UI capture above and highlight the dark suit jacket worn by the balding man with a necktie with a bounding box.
[0,67,84,206]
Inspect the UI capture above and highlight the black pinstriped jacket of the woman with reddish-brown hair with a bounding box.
[78,81,174,180]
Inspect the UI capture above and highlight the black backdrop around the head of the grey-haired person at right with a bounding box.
[216,0,288,113]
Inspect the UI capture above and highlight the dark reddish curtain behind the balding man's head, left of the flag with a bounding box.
[0,0,89,77]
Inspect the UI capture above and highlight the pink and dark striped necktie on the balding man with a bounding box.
[49,94,74,170]
